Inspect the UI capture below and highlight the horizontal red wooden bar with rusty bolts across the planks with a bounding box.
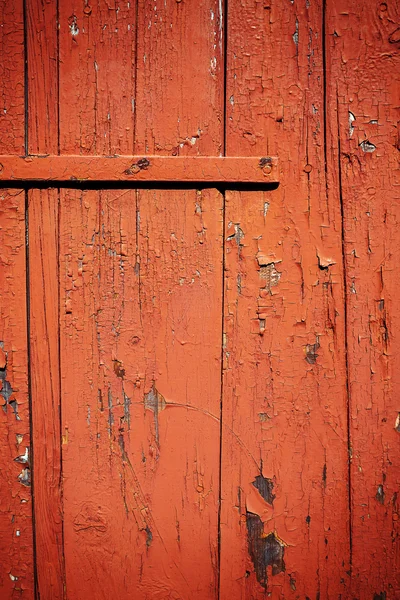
[0,155,279,183]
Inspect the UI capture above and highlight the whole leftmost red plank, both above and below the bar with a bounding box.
[0,0,34,599]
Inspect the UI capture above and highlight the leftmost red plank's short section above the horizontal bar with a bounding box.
[0,0,25,154]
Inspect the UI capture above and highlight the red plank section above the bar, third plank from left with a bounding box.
[59,0,136,156]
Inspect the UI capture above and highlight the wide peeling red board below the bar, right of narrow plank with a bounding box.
[60,190,222,600]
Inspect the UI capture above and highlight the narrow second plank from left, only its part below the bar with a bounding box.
[28,189,64,600]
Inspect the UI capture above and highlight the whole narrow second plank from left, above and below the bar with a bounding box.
[26,0,65,600]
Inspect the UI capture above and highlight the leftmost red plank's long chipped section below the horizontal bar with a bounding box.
[0,190,34,600]
